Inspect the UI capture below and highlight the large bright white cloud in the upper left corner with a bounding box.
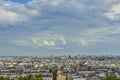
[0,1,38,24]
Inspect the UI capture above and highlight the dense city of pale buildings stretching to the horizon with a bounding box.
[0,55,120,80]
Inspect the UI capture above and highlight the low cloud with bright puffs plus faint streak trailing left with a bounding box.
[11,34,66,49]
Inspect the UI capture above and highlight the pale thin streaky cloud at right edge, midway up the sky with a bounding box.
[78,26,120,46]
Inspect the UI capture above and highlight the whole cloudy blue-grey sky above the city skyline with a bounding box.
[0,0,120,56]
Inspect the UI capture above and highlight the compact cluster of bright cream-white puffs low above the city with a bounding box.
[32,34,66,47]
